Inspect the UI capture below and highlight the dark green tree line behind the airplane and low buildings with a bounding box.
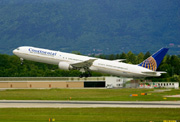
[0,51,180,82]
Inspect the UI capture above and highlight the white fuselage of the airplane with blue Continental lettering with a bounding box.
[13,46,160,77]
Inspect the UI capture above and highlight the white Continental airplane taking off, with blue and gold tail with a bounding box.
[13,46,169,78]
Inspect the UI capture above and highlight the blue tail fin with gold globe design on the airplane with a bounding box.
[138,48,169,71]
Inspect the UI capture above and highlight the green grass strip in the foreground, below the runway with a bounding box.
[0,108,180,122]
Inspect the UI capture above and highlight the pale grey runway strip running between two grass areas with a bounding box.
[0,100,180,108]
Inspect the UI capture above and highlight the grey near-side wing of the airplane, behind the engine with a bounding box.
[71,59,96,68]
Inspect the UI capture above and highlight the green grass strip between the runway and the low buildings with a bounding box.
[0,89,180,101]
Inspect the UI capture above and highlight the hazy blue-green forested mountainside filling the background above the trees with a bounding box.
[0,0,180,54]
